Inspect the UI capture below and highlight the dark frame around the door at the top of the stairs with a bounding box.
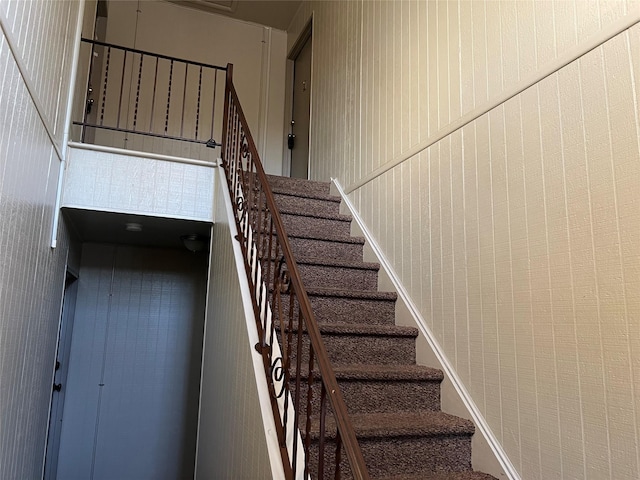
[282,13,314,177]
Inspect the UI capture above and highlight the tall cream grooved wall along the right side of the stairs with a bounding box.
[288,0,640,479]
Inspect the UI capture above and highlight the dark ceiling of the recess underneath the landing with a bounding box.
[62,208,211,248]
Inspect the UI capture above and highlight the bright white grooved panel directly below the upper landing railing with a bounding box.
[62,147,214,222]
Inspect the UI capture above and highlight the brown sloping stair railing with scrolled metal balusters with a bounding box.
[222,64,369,479]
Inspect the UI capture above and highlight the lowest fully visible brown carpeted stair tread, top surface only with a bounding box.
[311,410,475,440]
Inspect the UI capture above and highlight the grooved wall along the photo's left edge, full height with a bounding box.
[0,0,81,480]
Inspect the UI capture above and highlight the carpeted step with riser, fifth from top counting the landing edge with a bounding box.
[296,255,380,290]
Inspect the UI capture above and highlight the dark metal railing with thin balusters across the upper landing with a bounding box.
[73,38,227,147]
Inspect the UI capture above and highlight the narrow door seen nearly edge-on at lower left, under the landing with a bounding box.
[44,271,78,480]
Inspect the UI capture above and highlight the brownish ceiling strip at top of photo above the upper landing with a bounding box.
[169,0,302,30]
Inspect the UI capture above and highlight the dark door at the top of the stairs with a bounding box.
[289,35,311,178]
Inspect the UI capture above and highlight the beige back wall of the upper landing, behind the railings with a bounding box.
[86,0,286,174]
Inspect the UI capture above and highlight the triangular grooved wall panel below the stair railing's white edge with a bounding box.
[195,171,272,480]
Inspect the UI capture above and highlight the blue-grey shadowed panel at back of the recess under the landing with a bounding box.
[57,244,207,480]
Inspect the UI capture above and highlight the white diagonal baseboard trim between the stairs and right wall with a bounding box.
[331,178,521,480]
